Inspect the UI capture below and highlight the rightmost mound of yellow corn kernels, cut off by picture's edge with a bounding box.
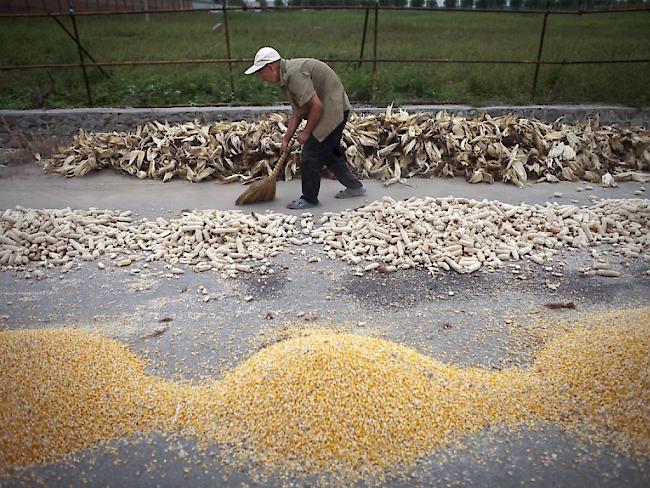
[529,308,650,454]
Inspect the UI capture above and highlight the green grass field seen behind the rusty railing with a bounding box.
[0,11,650,108]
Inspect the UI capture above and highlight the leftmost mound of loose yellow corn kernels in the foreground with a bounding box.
[0,329,179,472]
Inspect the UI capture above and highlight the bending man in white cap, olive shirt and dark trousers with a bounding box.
[245,47,366,209]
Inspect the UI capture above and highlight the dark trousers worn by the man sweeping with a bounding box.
[300,111,363,204]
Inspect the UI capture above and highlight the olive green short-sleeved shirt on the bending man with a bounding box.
[280,58,352,142]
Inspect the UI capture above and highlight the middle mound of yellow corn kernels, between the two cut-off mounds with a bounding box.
[186,332,523,474]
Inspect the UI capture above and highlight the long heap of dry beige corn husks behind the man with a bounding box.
[45,107,650,186]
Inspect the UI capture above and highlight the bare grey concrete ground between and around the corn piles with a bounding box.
[0,158,650,488]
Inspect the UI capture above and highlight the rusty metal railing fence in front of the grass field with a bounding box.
[0,0,650,106]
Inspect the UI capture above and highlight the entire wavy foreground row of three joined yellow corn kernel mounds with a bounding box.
[0,308,650,478]
